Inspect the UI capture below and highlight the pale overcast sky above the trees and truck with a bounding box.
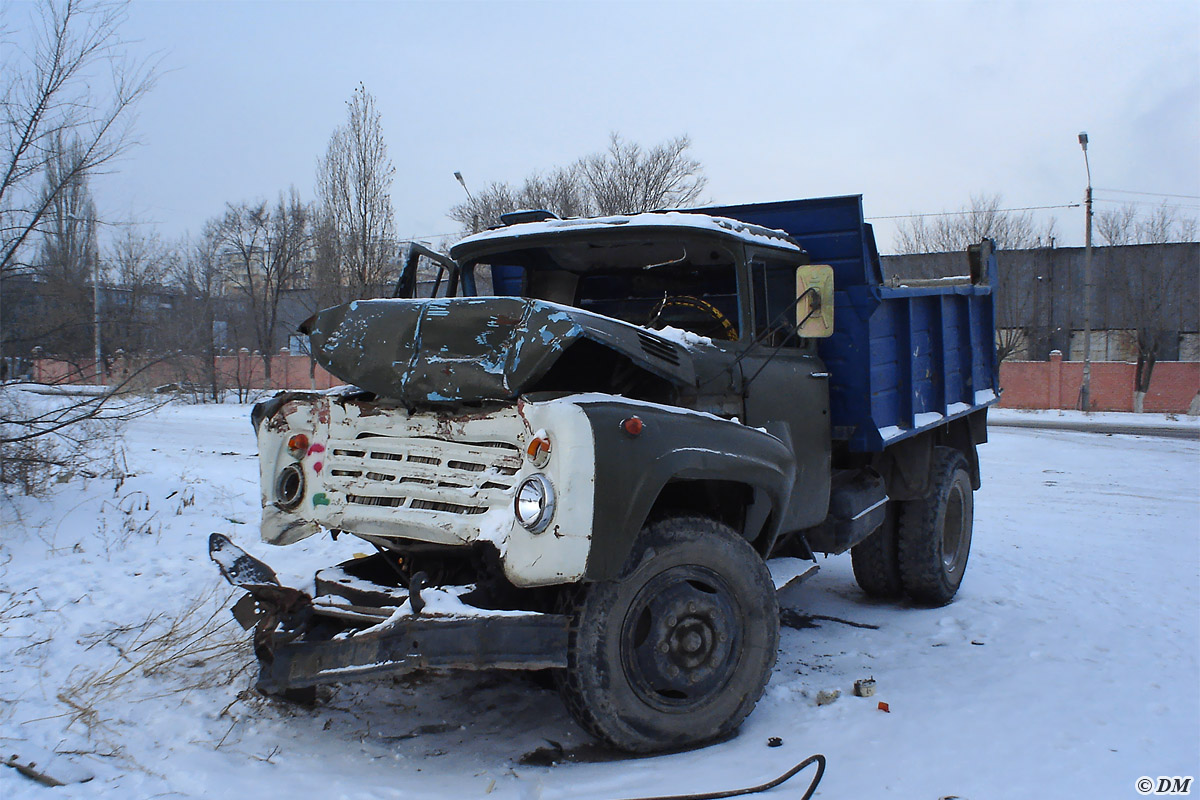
[56,0,1200,251]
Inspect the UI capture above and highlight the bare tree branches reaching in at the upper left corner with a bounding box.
[0,0,154,278]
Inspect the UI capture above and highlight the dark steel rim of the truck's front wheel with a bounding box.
[620,565,742,711]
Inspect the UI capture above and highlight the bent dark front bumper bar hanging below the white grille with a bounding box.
[209,534,569,693]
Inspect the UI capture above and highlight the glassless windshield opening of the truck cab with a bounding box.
[464,237,739,339]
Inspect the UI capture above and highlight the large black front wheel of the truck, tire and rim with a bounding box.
[558,516,779,752]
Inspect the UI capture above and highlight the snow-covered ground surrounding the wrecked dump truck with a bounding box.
[0,405,1200,800]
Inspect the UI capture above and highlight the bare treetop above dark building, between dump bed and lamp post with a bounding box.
[895,194,1056,254]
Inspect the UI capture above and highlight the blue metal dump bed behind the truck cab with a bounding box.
[703,194,998,451]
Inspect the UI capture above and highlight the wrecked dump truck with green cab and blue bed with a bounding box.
[209,196,997,752]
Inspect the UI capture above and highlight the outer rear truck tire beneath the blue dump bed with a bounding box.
[896,447,974,606]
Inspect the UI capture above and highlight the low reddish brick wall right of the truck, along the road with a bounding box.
[1000,353,1200,414]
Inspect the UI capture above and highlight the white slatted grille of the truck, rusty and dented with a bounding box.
[325,433,521,516]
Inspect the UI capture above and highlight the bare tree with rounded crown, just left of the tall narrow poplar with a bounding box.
[217,188,311,380]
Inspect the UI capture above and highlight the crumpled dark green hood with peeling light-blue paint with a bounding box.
[301,297,695,404]
